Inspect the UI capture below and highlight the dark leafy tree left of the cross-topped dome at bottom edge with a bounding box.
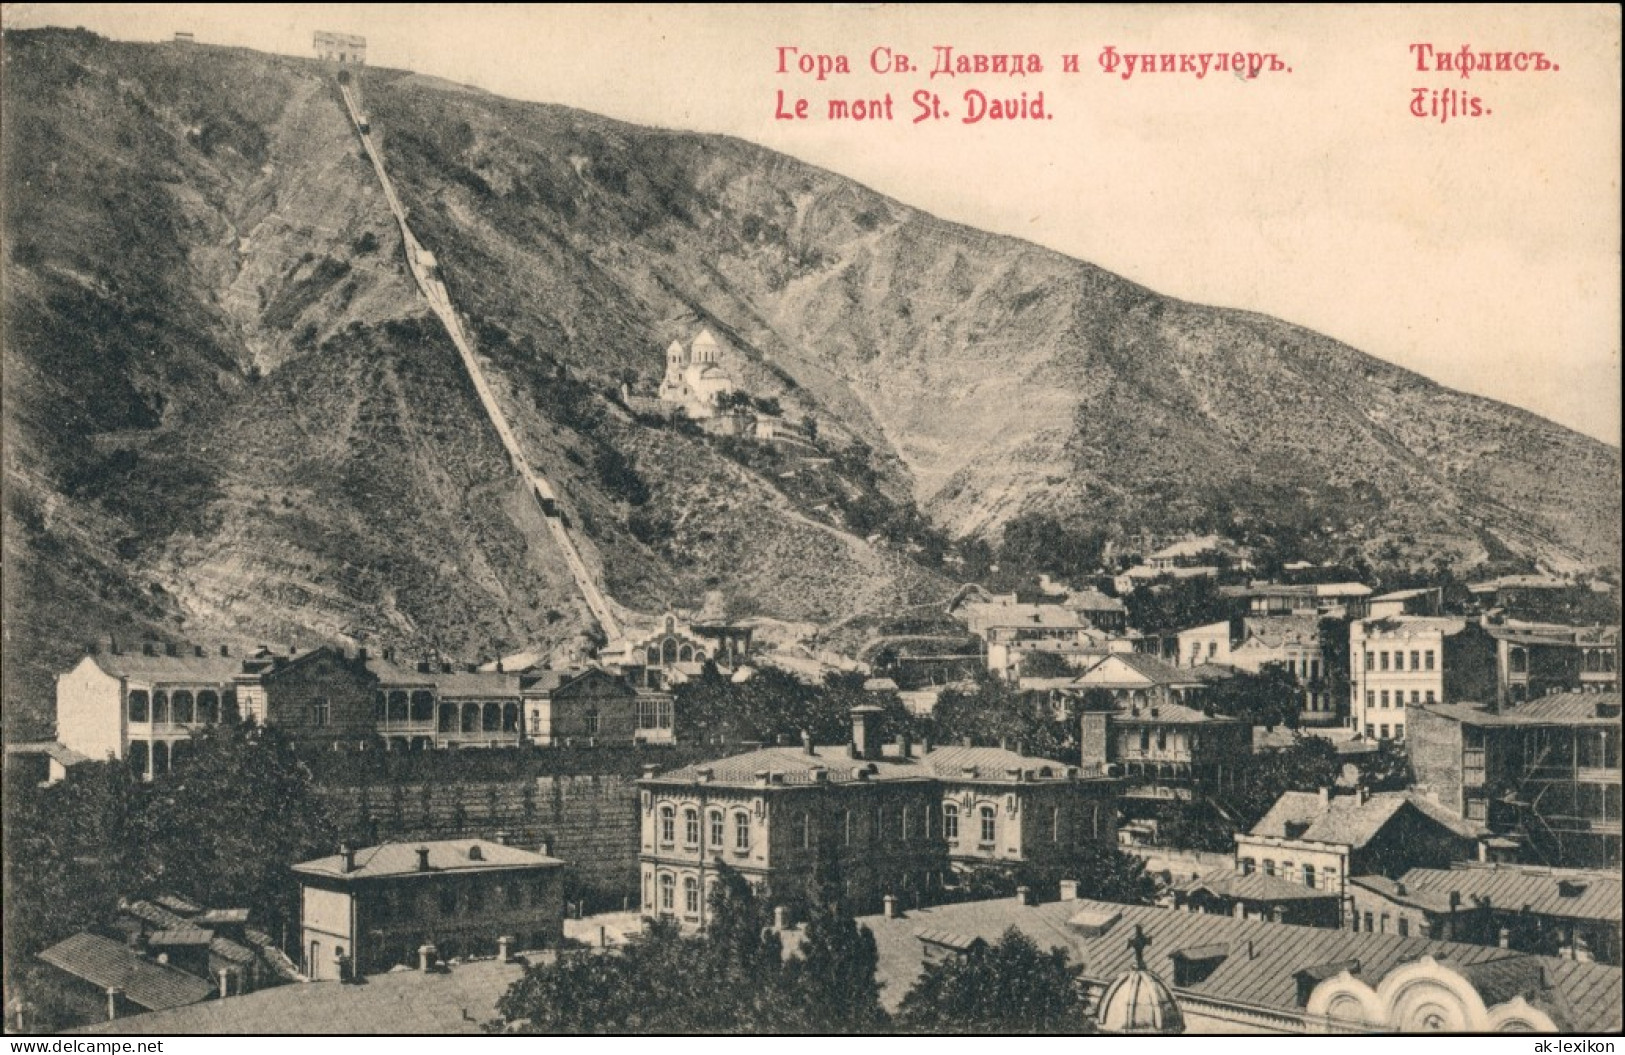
[897,927,1087,1035]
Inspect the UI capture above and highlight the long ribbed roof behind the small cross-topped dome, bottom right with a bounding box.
[863,897,1622,1032]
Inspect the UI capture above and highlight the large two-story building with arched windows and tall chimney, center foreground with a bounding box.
[640,707,1116,927]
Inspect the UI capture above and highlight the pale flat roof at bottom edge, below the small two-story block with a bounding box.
[78,961,525,1035]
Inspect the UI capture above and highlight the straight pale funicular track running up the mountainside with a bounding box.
[338,83,622,640]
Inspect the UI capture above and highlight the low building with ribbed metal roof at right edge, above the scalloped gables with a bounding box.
[1349,865,1622,967]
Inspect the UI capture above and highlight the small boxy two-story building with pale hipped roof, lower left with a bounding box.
[294,839,564,980]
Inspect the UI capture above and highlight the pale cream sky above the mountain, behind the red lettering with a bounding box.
[0,3,1620,445]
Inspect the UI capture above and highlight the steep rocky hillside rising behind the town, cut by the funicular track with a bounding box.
[3,31,1620,722]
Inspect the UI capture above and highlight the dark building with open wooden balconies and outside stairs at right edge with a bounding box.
[1411,692,1620,868]
